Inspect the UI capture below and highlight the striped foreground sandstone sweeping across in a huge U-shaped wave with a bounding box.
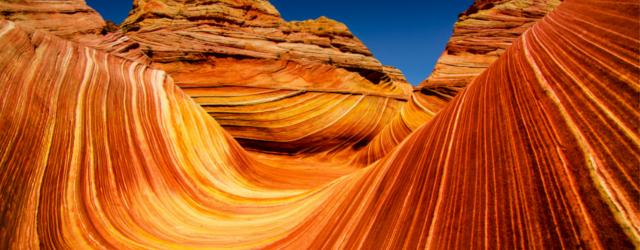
[0,0,640,249]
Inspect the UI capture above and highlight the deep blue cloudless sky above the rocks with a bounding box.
[87,0,473,84]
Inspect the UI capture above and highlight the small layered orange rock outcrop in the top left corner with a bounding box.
[0,0,106,41]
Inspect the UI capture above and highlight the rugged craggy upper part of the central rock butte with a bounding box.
[122,0,407,91]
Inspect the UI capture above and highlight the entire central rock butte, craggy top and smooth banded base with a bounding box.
[93,0,412,155]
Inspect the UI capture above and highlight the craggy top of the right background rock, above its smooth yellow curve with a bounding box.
[420,0,561,87]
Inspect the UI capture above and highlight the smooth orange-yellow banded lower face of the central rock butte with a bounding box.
[144,58,407,156]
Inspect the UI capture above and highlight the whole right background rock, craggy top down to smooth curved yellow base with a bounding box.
[353,0,560,160]
